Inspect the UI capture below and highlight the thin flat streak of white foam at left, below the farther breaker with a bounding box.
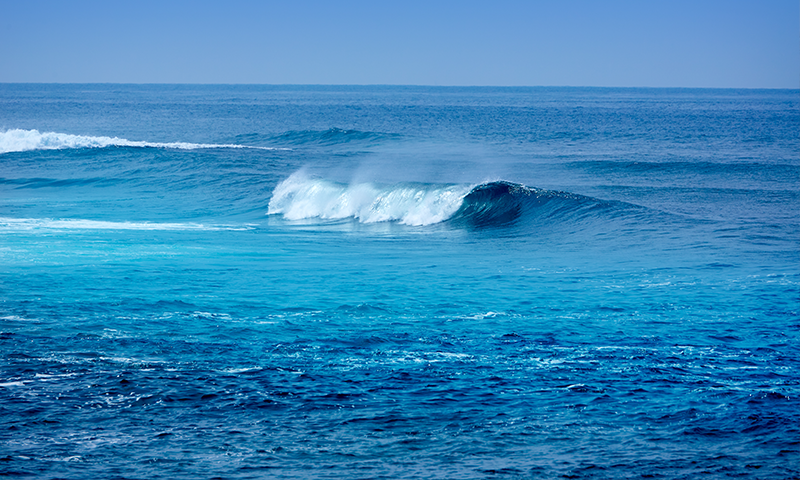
[0,217,253,231]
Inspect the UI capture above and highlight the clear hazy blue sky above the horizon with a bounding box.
[0,0,800,88]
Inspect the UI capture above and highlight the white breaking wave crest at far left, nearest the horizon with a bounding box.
[0,128,285,153]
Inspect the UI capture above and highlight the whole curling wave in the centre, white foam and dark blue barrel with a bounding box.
[268,172,620,228]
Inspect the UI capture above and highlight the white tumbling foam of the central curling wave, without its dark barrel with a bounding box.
[268,172,471,225]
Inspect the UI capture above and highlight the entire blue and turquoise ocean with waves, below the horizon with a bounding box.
[0,84,800,479]
